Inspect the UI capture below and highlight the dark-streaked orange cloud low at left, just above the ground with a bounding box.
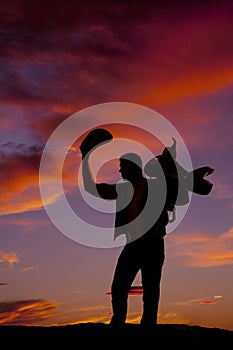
[0,300,57,325]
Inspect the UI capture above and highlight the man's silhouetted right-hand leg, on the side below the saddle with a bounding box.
[141,240,164,325]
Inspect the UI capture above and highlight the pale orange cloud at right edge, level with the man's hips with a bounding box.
[168,228,233,267]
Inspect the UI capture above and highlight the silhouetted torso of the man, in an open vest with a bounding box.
[114,178,168,241]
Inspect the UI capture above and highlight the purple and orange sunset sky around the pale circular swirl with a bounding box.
[0,0,233,330]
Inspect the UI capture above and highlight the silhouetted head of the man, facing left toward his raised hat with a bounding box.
[119,153,142,181]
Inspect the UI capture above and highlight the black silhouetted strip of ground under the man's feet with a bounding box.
[0,323,233,350]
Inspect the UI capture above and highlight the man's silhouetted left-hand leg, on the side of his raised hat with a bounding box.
[110,245,139,326]
